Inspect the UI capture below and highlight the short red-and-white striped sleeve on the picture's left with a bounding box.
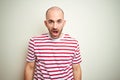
[26,38,35,62]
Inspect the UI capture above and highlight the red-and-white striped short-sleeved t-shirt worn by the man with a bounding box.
[26,33,81,80]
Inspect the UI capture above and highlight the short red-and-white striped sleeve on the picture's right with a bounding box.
[73,42,82,64]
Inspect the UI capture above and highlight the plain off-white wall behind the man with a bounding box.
[0,0,120,80]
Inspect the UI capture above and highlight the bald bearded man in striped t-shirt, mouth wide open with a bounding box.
[25,6,82,80]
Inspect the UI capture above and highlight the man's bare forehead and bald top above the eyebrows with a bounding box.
[46,8,64,20]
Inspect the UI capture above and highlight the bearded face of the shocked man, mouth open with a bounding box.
[45,9,65,39]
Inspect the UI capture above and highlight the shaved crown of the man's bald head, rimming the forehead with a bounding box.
[46,6,64,19]
